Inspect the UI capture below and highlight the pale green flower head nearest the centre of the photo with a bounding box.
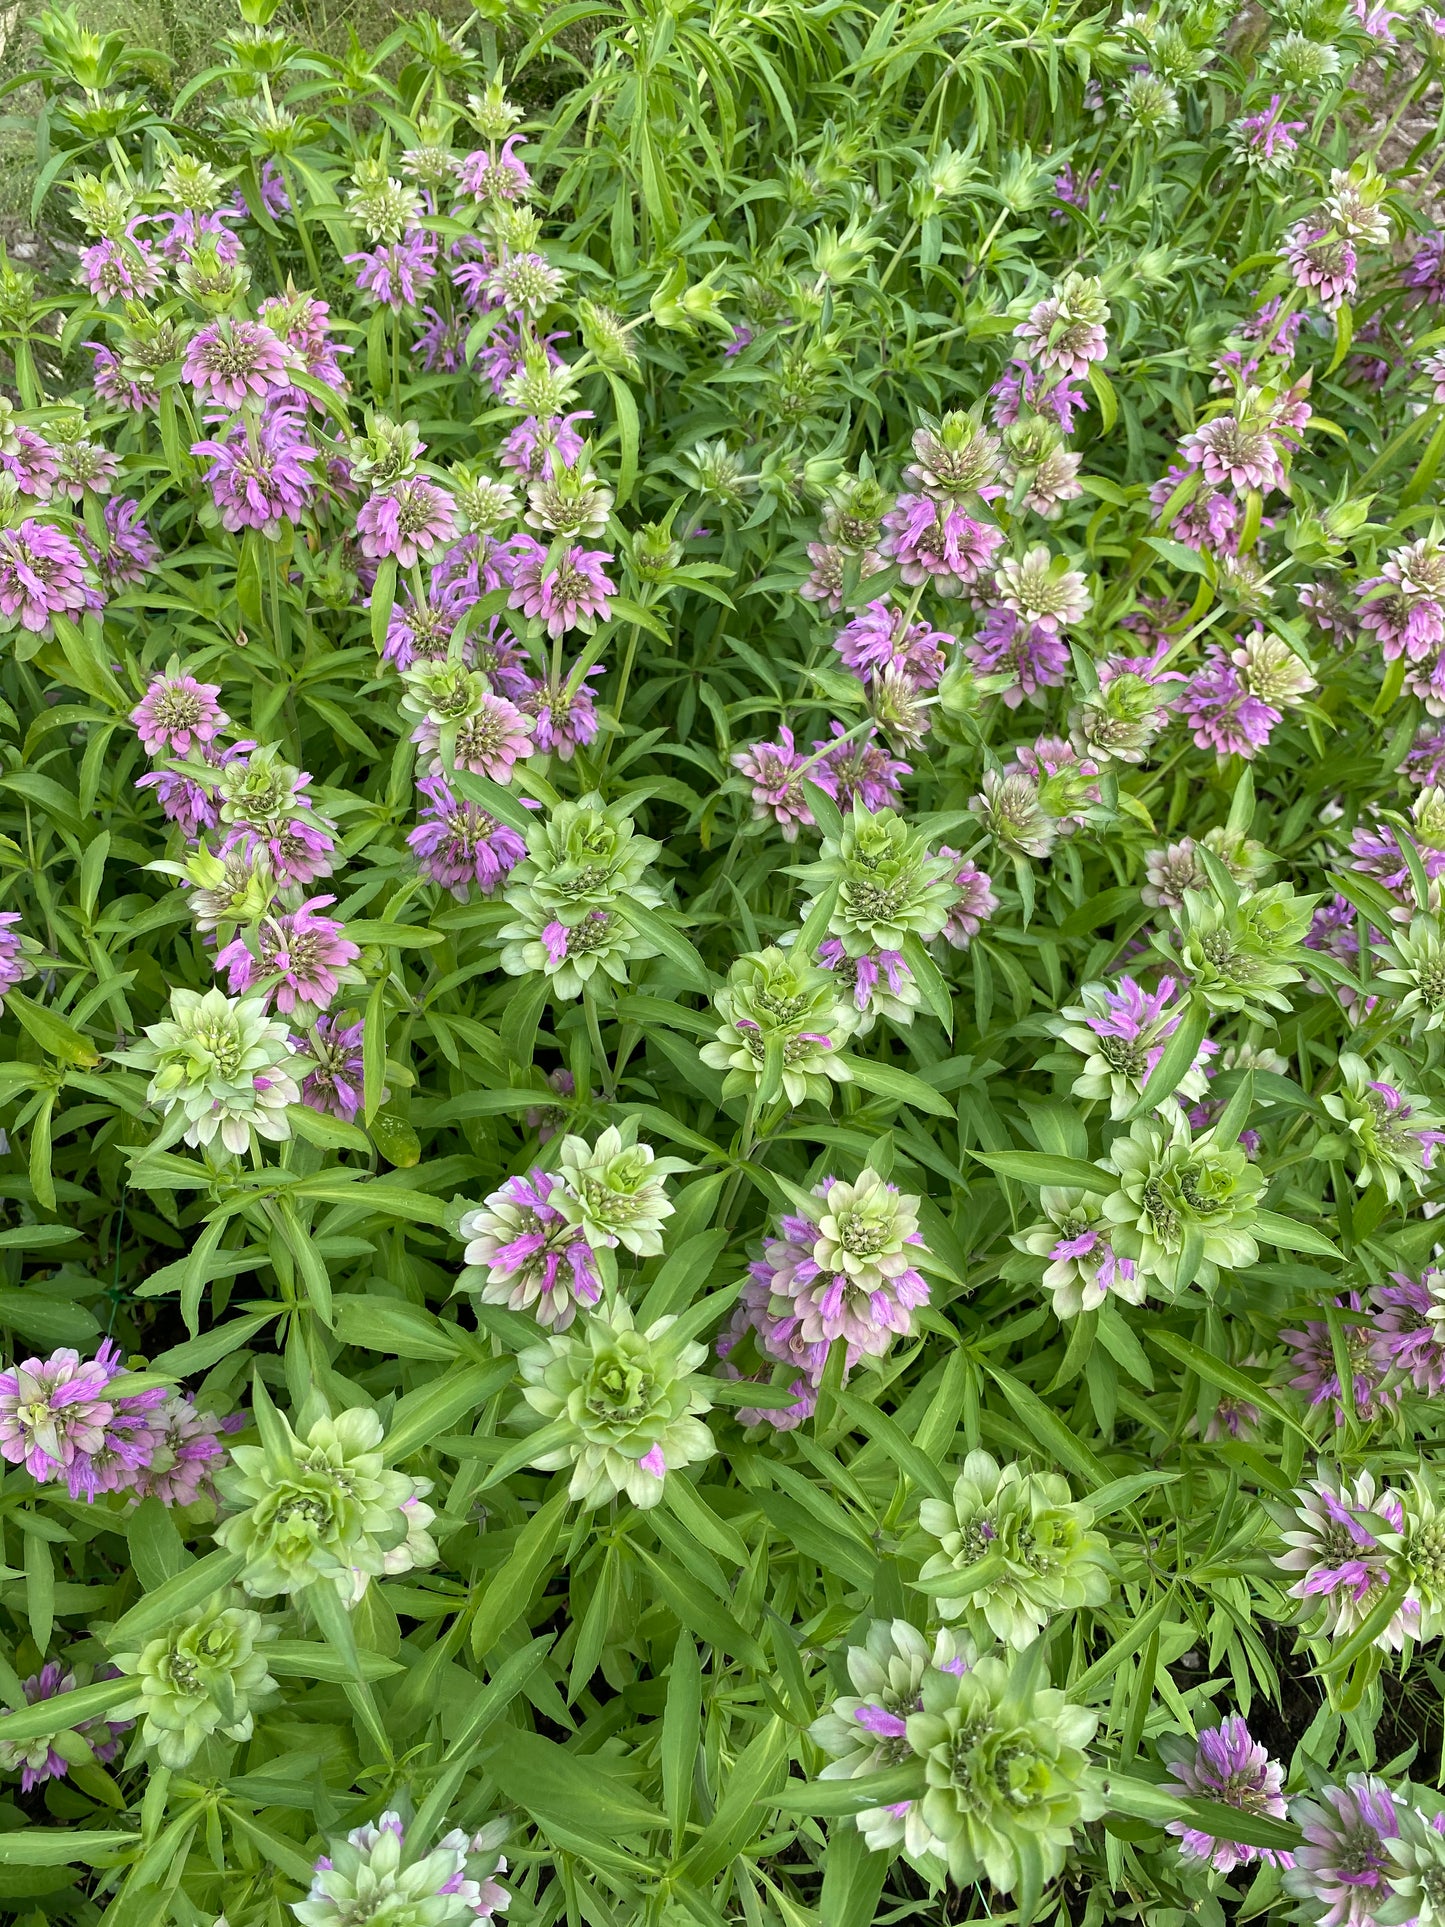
[699,948,857,1104]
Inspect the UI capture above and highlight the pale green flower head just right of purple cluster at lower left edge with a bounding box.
[216,1387,435,1601]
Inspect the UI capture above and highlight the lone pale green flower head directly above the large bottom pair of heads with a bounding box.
[919,1451,1114,1648]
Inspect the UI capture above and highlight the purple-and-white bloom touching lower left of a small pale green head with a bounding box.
[459,1166,601,1332]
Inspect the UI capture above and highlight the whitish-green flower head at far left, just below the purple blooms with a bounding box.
[116,989,301,1156]
